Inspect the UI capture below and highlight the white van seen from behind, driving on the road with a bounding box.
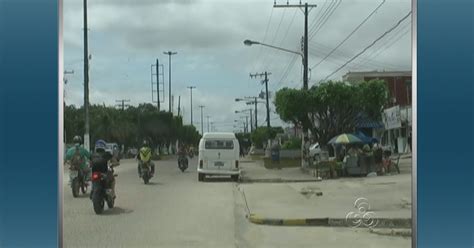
[197,133,240,181]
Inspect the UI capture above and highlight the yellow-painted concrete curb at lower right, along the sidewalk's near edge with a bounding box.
[247,214,412,228]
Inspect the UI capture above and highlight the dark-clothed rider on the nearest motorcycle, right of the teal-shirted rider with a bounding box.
[91,142,119,198]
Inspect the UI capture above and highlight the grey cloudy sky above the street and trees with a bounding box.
[63,0,411,131]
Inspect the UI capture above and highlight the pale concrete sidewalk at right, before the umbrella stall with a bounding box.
[239,157,411,228]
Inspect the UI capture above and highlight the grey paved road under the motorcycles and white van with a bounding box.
[63,158,410,248]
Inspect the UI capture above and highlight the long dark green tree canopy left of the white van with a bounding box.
[64,104,201,148]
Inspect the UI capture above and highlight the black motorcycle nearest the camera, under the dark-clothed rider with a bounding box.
[91,167,117,214]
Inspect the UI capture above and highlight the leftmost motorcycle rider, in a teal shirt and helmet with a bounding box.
[65,135,91,181]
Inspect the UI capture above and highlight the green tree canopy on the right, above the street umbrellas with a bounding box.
[275,80,388,145]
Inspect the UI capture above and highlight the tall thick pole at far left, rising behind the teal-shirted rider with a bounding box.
[83,0,90,151]
